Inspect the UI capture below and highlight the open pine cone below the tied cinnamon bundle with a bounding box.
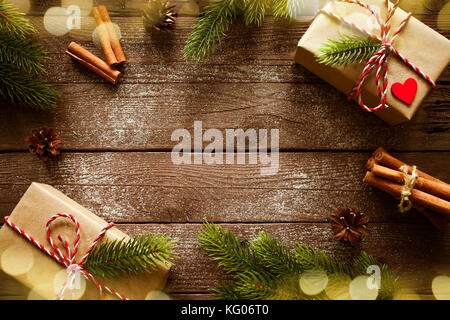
[329,208,369,245]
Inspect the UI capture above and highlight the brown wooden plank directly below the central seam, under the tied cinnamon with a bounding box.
[0,152,450,228]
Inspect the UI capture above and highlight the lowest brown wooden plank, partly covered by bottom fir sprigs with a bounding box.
[118,223,450,294]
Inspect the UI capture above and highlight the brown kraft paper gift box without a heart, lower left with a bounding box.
[0,183,171,299]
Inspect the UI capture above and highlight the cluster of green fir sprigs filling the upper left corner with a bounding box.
[0,0,59,110]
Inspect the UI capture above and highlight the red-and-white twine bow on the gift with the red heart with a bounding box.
[320,0,436,112]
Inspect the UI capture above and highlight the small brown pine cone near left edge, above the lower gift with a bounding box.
[25,126,62,161]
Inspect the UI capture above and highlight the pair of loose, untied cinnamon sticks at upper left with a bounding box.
[66,6,126,84]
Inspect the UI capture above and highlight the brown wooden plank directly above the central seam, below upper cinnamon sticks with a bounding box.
[0,83,450,151]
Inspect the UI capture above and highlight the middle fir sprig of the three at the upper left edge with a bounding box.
[0,33,49,74]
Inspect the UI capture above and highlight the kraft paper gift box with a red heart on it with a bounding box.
[295,0,450,125]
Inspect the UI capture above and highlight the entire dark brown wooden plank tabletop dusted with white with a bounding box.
[0,0,450,299]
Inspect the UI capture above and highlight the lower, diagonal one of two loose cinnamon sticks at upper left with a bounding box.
[66,42,122,84]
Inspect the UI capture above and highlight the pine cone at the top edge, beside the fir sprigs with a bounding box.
[142,0,178,32]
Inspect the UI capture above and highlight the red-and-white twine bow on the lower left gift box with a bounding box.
[5,212,128,300]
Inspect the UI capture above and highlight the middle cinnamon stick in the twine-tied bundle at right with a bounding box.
[371,164,450,200]
